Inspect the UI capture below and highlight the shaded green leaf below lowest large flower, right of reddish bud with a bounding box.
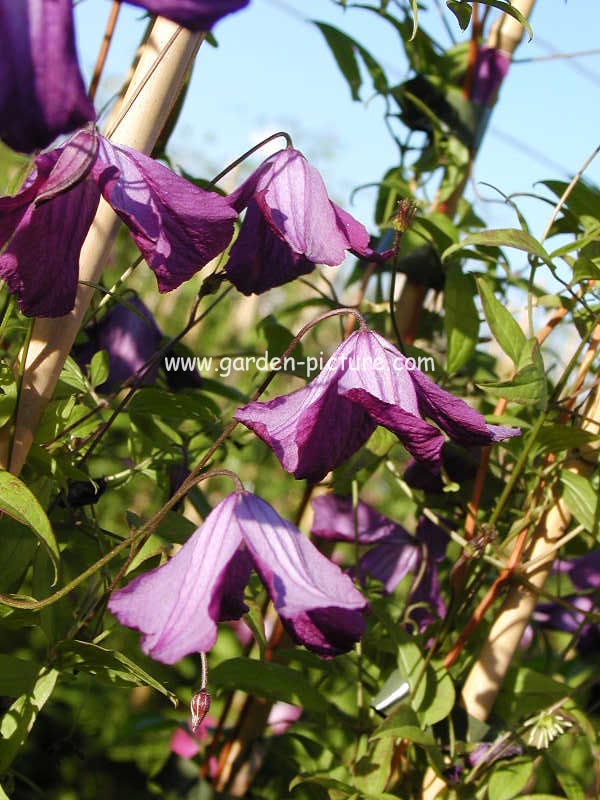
[210,658,327,712]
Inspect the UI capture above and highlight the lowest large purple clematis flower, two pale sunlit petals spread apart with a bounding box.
[108,492,366,664]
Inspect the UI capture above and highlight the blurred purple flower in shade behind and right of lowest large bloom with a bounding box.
[311,495,448,632]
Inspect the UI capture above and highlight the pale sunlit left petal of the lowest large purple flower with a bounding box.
[108,494,242,664]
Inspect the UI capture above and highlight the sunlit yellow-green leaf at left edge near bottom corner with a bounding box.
[0,667,59,774]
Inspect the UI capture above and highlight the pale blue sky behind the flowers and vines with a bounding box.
[77,0,600,235]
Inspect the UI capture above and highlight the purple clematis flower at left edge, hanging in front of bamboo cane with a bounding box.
[0,129,236,317]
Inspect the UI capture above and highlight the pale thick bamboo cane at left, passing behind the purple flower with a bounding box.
[0,17,205,474]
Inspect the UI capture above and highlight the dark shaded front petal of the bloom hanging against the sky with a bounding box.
[225,200,315,295]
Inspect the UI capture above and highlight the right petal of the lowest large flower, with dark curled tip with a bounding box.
[236,493,367,656]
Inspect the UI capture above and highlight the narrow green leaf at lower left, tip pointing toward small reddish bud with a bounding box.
[57,639,178,706]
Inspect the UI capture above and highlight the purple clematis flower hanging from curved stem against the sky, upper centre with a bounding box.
[225,148,391,295]
